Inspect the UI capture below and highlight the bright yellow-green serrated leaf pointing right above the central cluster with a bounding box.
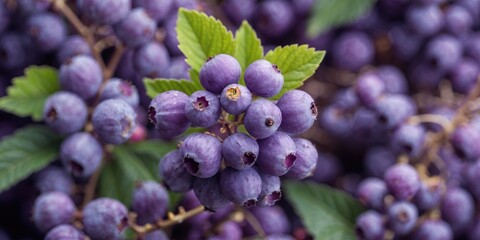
[265,44,325,99]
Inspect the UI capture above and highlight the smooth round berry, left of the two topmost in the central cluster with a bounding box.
[200,54,242,94]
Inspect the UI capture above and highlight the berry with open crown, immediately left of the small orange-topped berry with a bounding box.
[185,90,222,128]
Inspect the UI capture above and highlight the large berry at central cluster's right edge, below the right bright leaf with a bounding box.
[277,90,318,134]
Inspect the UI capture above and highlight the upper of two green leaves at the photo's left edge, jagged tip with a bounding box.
[0,66,60,121]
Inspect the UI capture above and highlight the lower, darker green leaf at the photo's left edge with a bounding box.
[0,126,61,192]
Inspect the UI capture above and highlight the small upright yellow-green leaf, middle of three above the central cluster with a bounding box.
[235,21,263,85]
